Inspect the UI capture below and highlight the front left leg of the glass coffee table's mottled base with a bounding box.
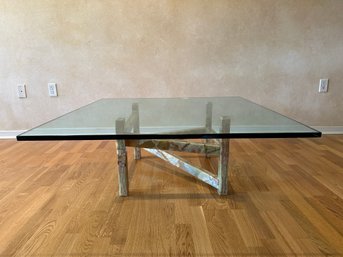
[116,118,128,196]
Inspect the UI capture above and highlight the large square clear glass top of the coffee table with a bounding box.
[17,97,321,141]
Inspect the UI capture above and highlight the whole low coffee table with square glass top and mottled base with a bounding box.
[17,97,321,196]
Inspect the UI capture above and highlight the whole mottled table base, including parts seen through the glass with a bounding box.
[116,103,230,196]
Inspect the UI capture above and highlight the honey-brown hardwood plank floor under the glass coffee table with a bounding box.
[0,136,343,257]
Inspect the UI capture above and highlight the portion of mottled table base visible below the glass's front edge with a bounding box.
[117,136,229,196]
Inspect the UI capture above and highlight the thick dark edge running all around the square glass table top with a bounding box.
[16,96,322,141]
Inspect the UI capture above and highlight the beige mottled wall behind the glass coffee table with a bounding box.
[0,0,343,130]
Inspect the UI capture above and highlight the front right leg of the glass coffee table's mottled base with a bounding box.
[218,117,230,195]
